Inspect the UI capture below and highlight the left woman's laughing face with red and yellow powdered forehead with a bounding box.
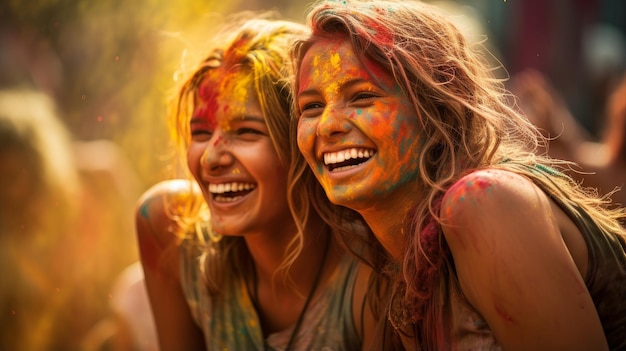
[187,70,292,235]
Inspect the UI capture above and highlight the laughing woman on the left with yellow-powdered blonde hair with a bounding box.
[137,14,374,350]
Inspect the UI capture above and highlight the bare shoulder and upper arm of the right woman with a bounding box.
[441,170,608,350]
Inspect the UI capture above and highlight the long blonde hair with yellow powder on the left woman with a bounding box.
[170,12,378,302]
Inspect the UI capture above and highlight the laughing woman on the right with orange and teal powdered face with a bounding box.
[293,0,626,350]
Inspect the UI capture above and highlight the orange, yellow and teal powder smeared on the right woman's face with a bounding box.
[298,37,418,205]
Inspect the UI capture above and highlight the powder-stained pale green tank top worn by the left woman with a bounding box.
[181,239,361,351]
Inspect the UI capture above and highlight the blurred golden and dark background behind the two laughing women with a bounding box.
[0,0,626,350]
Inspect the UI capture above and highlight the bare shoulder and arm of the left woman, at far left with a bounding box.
[135,180,206,351]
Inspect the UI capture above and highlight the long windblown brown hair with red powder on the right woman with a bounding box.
[292,0,624,350]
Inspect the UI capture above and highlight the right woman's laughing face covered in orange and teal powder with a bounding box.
[296,37,420,212]
